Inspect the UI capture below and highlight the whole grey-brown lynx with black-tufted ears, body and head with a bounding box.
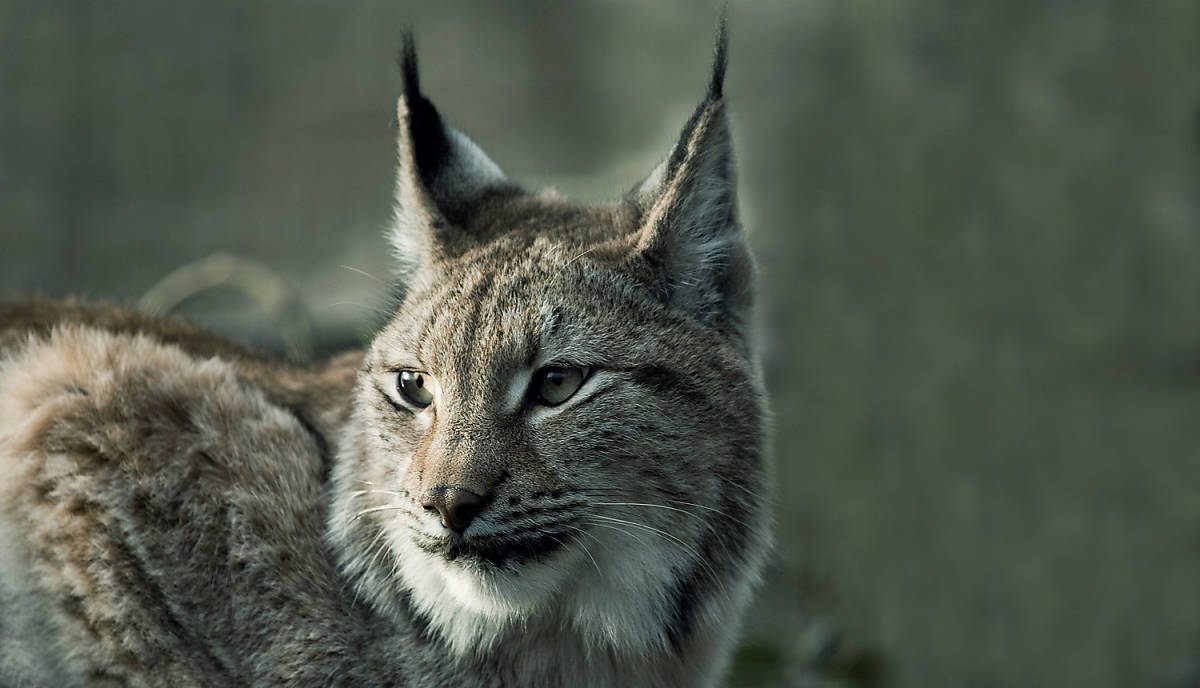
[0,26,770,688]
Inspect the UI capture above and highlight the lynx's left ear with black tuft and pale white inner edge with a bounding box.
[391,34,517,275]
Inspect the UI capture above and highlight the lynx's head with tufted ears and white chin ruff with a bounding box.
[331,25,769,667]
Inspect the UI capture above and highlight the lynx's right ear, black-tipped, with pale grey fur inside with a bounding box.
[632,20,752,323]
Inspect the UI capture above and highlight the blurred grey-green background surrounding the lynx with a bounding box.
[0,0,1200,688]
